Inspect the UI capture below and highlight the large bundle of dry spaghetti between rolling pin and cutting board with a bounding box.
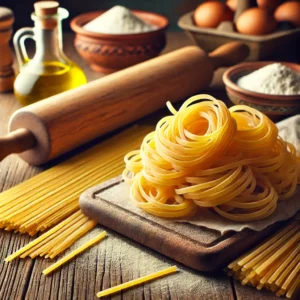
[0,126,149,238]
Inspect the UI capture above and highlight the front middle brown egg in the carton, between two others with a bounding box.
[236,7,277,35]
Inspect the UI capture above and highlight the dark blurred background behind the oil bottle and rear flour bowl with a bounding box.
[0,0,212,31]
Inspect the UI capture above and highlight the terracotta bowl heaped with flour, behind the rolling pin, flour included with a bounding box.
[70,5,169,73]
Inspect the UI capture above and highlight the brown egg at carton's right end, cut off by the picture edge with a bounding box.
[274,1,300,27]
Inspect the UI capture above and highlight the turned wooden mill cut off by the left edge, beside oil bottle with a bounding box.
[0,6,15,93]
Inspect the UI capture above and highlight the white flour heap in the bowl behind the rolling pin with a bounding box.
[83,5,157,34]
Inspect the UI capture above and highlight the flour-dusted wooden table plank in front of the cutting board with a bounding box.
[25,226,234,300]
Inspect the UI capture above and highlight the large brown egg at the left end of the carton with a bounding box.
[194,1,233,28]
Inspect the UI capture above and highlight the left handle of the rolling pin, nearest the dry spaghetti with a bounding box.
[0,128,36,161]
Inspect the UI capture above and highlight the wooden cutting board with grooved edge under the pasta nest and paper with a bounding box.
[80,177,283,271]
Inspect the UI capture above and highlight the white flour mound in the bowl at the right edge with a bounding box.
[237,63,300,95]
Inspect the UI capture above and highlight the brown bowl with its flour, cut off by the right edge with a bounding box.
[223,62,300,119]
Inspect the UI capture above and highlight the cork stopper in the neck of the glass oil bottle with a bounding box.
[34,1,59,29]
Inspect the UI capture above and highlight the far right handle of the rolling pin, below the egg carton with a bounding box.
[209,42,250,69]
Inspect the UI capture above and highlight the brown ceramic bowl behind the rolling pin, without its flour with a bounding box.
[70,10,169,73]
